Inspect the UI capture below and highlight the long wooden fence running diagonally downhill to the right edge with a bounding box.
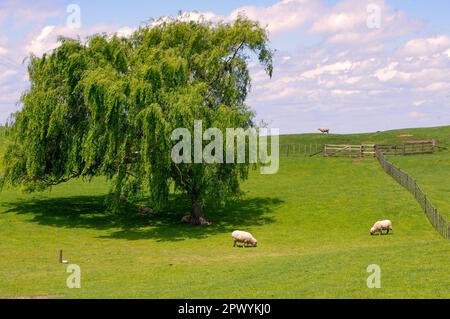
[375,149,450,239]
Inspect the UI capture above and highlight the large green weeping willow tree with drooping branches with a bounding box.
[1,17,272,223]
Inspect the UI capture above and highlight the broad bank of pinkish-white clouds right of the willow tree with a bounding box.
[237,0,450,133]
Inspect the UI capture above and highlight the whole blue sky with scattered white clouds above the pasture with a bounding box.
[0,0,450,133]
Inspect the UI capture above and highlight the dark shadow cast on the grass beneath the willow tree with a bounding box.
[5,196,283,241]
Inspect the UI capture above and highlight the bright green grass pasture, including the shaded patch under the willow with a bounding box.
[0,128,450,298]
